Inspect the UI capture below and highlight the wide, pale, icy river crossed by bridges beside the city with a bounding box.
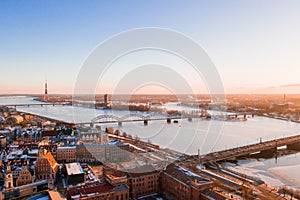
[0,96,300,188]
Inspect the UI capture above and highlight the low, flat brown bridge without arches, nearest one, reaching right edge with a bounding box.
[191,135,300,164]
